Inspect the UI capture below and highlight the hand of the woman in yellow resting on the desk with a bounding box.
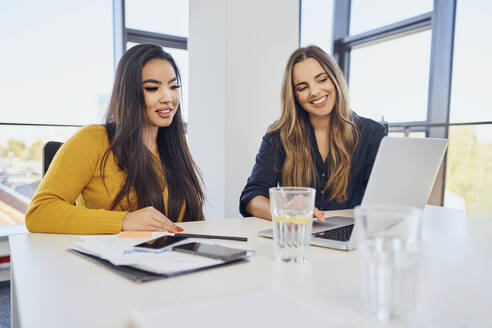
[121,206,183,233]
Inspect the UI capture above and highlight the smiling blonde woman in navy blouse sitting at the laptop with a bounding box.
[240,46,387,220]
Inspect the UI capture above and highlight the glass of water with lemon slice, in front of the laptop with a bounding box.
[269,187,316,262]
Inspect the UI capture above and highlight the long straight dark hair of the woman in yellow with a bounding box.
[101,44,204,221]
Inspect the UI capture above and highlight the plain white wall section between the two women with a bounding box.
[188,0,299,219]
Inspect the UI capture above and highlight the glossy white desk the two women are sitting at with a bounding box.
[10,206,492,327]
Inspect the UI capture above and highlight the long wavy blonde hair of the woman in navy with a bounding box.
[269,46,359,202]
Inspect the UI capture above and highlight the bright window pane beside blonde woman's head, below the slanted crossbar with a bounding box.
[349,31,431,122]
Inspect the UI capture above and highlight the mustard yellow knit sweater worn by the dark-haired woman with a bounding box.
[26,125,185,234]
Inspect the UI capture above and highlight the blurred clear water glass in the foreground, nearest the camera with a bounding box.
[354,205,422,321]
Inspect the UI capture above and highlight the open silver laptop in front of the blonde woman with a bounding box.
[258,137,448,250]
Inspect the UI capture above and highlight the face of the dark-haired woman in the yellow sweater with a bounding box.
[142,58,180,127]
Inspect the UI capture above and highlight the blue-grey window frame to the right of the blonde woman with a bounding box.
[326,0,456,205]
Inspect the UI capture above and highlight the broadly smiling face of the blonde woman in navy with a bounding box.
[292,57,337,120]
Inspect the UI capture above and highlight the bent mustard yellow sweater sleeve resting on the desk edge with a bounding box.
[26,126,128,234]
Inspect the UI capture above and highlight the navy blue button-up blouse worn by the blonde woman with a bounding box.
[239,113,388,216]
